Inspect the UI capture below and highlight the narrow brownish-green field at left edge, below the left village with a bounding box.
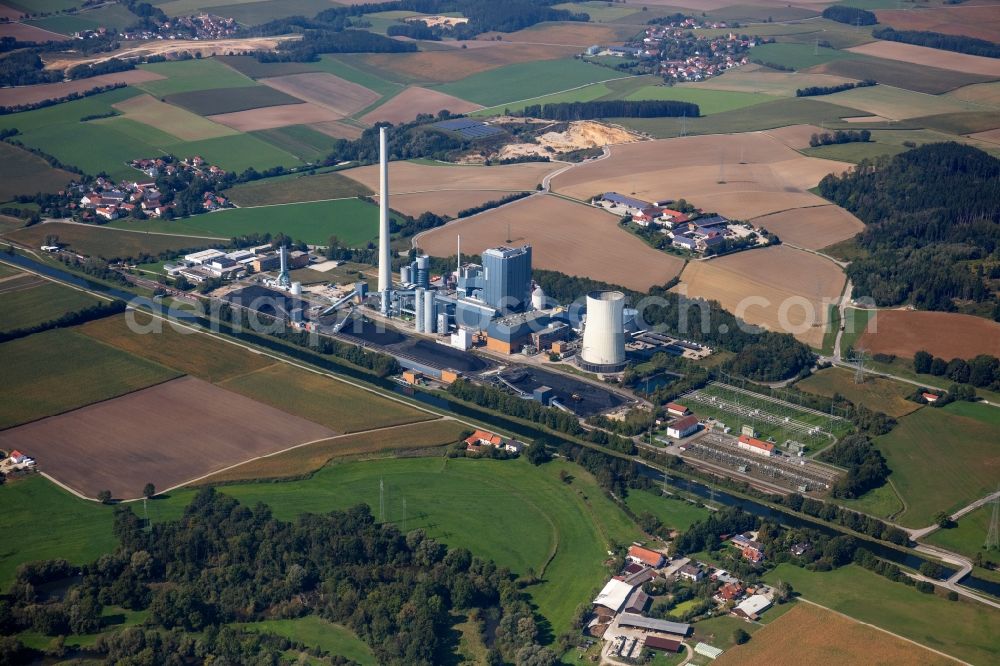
[3,222,213,259]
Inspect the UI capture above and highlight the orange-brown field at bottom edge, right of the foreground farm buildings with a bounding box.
[713,601,958,666]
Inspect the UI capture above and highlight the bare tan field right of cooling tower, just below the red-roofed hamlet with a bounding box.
[674,245,847,347]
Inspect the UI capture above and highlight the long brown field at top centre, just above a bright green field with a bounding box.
[361,42,579,83]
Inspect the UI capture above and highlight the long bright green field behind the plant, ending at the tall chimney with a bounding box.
[111,199,386,247]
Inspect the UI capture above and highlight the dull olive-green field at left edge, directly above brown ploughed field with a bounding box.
[0,328,180,429]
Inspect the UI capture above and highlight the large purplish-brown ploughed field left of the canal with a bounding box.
[0,377,334,499]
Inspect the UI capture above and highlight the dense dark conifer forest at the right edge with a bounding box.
[819,142,1000,316]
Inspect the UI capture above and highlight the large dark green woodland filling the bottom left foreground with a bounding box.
[0,489,555,666]
